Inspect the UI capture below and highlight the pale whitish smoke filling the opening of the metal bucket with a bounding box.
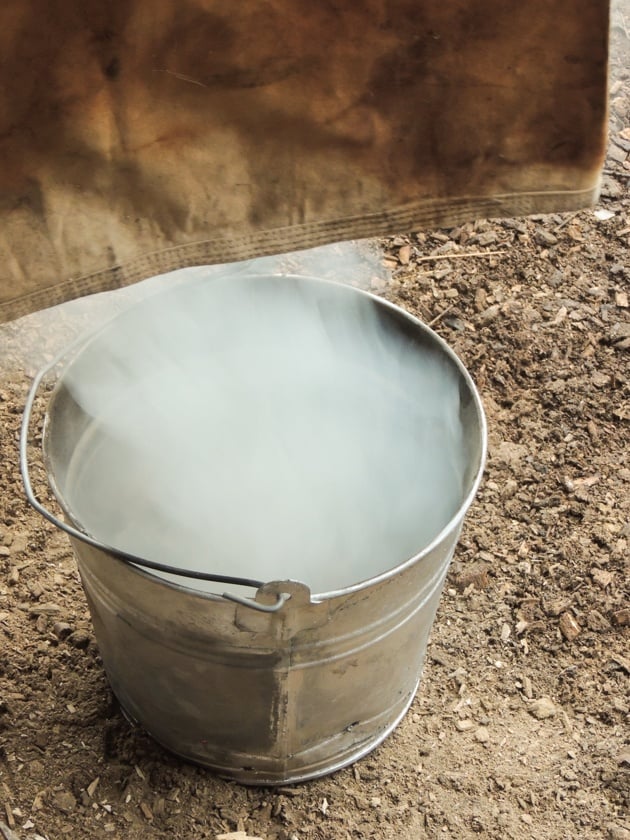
[57,276,467,595]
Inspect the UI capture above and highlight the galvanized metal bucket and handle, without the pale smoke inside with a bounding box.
[21,277,486,785]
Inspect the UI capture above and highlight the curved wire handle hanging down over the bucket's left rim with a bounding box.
[20,352,291,613]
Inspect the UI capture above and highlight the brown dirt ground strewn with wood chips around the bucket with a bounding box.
[0,15,630,840]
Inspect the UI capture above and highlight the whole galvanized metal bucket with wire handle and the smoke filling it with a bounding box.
[21,275,486,784]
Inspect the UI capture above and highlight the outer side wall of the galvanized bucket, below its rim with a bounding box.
[75,534,457,784]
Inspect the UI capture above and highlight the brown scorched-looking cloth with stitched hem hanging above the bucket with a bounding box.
[0,0,608,320]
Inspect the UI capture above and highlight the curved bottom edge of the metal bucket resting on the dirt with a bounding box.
[117,679,420,787]
